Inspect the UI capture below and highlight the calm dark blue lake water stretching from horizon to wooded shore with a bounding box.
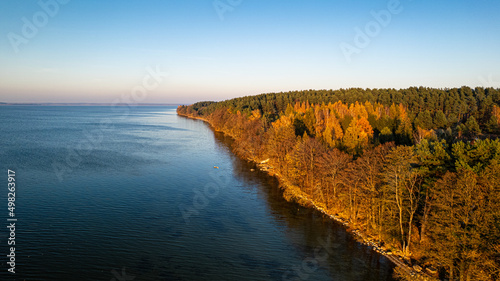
[0,106,393,281]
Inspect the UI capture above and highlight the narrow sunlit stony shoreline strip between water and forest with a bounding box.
[177,110,439,281]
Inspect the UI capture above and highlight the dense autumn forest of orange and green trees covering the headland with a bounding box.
[178,87,500,280]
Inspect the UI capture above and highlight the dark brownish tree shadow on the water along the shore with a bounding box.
[209,132,395,280]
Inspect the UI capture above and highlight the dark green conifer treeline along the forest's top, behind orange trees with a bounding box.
[183,87,500,136]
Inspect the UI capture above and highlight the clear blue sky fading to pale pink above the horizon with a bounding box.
[0,0,500,103]
